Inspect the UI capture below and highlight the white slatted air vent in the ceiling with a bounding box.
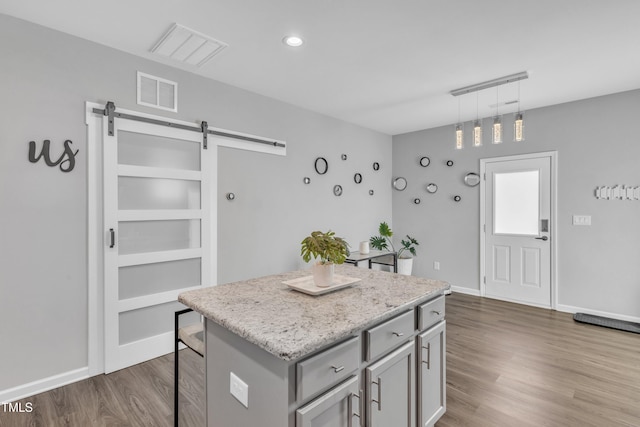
[151,24,228,67]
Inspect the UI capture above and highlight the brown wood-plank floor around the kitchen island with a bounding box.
[0,294,640,427]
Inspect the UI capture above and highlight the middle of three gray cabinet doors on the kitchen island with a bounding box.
[365,341,415,427]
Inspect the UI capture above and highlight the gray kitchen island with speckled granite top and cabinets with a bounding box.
[179,265,449,427]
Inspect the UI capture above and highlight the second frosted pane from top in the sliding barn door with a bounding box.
[118,176,200,210]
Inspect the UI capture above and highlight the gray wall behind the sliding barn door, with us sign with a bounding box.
[0,15,391,392]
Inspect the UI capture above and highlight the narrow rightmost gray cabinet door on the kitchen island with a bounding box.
[417,322,447,427]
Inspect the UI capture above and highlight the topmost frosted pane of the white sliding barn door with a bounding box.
[118,131,201,171]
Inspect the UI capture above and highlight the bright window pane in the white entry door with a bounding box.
[493,170,540,236]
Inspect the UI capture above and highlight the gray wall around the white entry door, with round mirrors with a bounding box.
[393,91,640,318]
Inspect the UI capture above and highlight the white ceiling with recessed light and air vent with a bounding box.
[0,0,640,135]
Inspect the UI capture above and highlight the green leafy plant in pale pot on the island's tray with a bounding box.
[300,230,349,288]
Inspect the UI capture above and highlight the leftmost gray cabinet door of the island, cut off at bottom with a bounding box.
[296,375,361,427]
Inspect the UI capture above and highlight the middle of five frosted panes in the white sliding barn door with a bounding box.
[118,219,200,255]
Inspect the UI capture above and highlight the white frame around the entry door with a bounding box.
[479,151,560,310]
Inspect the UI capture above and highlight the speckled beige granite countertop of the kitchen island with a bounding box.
[178,264,449,361]
